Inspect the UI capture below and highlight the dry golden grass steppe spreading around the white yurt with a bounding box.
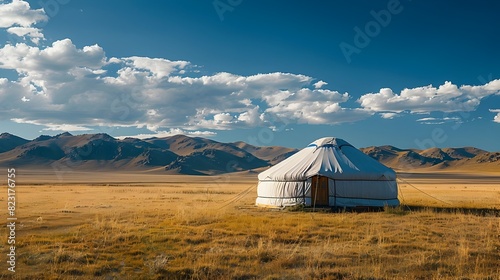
[0,171,500,279]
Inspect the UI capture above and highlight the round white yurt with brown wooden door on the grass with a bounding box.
[256,137,399,207]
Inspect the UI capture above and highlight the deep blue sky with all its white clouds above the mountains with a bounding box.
[0,0,500,151]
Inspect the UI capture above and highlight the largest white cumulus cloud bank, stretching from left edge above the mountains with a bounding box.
[0,39,371,132]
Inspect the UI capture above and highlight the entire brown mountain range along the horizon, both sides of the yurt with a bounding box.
[0,132,500,175]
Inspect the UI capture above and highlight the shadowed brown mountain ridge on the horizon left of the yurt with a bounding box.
[0,132,297,175]
